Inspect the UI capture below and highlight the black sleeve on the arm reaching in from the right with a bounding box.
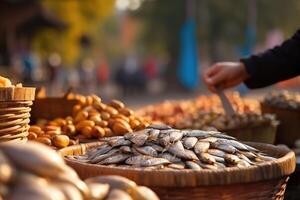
[241,30,300,88]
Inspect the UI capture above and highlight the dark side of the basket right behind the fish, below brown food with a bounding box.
[222,122,278,144]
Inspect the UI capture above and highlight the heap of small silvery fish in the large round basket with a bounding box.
[67,124,275,170]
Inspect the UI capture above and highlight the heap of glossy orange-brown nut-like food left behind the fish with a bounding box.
[29,95,149,148]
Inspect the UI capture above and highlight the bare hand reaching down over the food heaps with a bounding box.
[203,62,249,92]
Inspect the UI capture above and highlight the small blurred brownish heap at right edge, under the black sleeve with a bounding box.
[263,91,300,109]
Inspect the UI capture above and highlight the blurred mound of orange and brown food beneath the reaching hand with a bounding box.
[138,93,278,131]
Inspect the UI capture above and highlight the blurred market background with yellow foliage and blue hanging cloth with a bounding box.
[0,0,300,105]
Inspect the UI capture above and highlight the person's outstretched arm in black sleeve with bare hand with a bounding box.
[203,30,300,92]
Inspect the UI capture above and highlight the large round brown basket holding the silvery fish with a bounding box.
[59,142,295,200]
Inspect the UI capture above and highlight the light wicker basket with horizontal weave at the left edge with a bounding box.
[0,87,35,143]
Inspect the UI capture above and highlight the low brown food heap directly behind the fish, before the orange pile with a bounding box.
[174,112,278,132]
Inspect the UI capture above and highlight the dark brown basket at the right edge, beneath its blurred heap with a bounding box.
[261,103,300,147]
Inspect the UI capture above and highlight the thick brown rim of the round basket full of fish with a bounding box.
[58,142,296,187]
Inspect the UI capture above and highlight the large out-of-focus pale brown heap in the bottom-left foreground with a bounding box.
[0,142,158,200]
